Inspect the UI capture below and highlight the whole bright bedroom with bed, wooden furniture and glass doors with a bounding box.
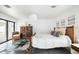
[0,5,79,54]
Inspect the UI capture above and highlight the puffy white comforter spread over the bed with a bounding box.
[32,34,71,49]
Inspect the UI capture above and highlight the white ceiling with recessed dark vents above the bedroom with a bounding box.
[0,5,73,19]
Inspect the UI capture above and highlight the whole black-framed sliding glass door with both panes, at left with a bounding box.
[0,18,15,43]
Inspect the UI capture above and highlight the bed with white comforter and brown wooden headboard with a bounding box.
[32,26,74,49]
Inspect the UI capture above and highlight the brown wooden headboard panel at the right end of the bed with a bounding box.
[65,26,76,43]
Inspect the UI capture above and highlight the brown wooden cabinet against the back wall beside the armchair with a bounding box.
[20,24,32,38]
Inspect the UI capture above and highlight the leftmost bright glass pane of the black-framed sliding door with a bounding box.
[0,20,6,43]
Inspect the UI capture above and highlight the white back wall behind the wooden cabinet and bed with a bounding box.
[17,19,55,33]
